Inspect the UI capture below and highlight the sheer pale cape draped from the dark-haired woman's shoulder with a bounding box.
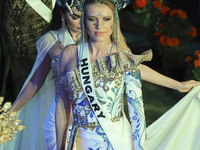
[0,29,74,150]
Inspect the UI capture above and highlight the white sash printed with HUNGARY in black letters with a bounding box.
[78,43,126,150]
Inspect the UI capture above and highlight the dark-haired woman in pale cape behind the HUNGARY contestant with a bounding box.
[0,1,80,150]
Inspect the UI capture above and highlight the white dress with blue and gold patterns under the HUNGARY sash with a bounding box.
[61,46,152,150]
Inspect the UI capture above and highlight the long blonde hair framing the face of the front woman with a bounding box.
[81,0,130,51]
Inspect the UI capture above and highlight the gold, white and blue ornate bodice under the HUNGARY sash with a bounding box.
[61,51,151,127]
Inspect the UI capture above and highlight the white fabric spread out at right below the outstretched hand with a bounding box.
[147,86,200,150]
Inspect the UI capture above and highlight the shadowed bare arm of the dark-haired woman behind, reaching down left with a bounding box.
[9,54,51,112]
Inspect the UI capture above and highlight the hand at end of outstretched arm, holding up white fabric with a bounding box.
[177,80,200,93]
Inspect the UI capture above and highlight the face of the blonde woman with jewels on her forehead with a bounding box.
[85,4,114,42]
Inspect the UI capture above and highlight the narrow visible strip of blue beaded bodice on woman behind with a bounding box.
[51,55,60,100]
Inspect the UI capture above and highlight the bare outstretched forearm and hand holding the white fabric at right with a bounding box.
[140,64,200,92]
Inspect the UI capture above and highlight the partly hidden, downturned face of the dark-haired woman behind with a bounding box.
[61,6,81,33]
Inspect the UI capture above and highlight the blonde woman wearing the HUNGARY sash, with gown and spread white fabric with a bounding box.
[56,0,200,150]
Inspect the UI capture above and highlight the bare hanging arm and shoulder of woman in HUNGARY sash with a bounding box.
[55,47,72,150]
